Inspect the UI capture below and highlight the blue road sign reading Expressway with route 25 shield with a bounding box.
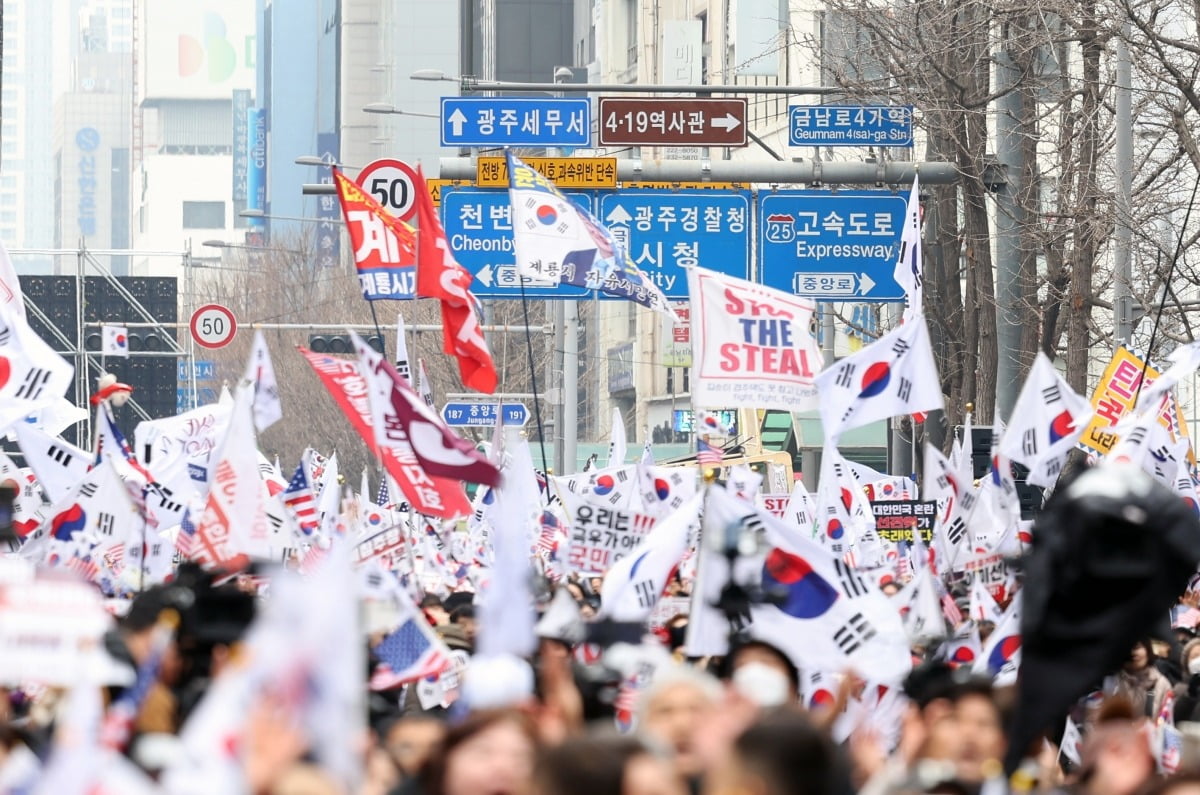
[758,191,907,301]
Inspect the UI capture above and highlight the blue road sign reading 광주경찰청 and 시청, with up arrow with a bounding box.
[600,190,751,300]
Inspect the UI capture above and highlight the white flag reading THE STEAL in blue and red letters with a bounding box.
[688,268,822,411]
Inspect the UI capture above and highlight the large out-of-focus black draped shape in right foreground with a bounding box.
[1004,462,1200,773]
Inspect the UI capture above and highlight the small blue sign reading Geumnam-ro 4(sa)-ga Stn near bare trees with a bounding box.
[787,104,912,147]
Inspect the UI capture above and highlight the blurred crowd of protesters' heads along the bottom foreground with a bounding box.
[7,559,1200,795]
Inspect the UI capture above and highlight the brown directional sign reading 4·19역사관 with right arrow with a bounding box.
[599,96,746,147]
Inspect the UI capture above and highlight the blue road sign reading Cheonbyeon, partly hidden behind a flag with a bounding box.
[442,187,592,299]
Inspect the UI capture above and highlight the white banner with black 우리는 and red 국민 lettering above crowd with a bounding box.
[562,491,655,574]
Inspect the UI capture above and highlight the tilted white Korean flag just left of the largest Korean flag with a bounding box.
[598,494,701,621]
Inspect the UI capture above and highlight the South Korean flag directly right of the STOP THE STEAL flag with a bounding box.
[817,315,943,440]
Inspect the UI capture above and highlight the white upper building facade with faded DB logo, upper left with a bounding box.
[140,0,256,100]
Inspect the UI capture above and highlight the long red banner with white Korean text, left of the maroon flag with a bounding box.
[300,347,470,519]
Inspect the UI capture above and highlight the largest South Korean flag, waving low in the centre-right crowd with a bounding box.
[703,486,912,682]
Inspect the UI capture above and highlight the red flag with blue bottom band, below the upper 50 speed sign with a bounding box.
[334,168,416,301]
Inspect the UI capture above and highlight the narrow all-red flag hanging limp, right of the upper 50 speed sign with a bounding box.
[413,166,497,394]
